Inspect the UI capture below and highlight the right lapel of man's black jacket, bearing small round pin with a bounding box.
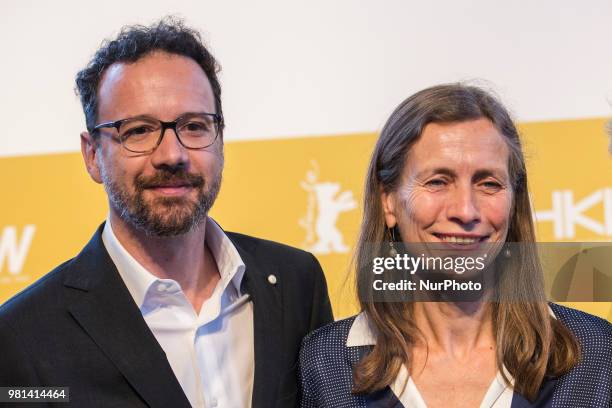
[230,235,284,408]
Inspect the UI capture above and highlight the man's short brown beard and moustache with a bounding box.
[102,169,221,237]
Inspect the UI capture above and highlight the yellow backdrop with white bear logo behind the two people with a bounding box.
[0,119,612,321]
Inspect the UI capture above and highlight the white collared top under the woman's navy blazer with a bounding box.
[346,312,514,408]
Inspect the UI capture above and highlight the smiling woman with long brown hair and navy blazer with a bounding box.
[300,84,612,407]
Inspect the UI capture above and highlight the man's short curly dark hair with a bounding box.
[75,16,224,133]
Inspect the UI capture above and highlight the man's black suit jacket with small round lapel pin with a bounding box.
[0,226,333,408]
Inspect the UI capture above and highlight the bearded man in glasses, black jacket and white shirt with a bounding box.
[0,19,332,408]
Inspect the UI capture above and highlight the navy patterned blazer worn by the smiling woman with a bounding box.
[299,304,612,408]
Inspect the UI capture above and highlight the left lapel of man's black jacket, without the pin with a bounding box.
[65,225,190,407]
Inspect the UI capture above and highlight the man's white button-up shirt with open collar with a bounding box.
[102,218,255,408]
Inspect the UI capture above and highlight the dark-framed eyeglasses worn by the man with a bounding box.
[93,112,222,153]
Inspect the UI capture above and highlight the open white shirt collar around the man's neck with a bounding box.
[102,217,245,307]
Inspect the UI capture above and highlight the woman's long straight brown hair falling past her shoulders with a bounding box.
[353,84,580,401]
